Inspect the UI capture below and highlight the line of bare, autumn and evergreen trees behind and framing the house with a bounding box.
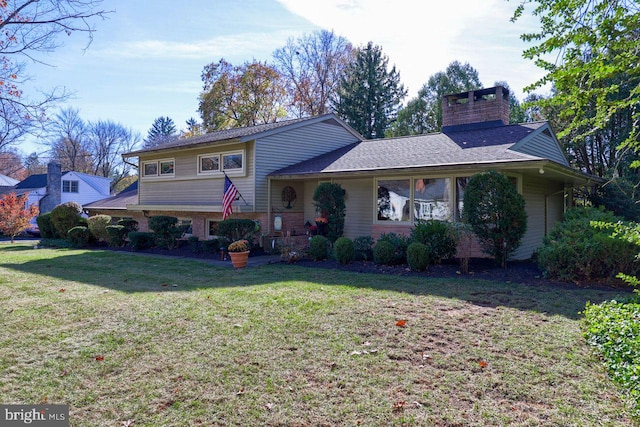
[0,0,640,207]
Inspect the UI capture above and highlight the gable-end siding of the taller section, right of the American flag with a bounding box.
[255,123,357,211]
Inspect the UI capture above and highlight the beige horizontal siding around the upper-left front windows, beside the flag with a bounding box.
[138,142,254,211]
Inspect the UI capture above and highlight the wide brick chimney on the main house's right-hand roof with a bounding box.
[442,86,509,132]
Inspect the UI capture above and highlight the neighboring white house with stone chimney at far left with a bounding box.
[14,163,111,213]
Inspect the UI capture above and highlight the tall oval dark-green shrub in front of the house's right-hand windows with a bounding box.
[462,170,527,267]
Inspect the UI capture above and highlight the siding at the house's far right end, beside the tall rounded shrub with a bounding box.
[513,176,562,259]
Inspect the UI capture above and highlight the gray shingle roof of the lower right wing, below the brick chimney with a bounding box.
[271,123,544,176]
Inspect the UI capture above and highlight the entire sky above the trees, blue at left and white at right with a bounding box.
[18,0,542,157]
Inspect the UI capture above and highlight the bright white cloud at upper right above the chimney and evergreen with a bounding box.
[278,0,541,100]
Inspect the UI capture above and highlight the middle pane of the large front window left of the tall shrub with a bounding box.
[413,178,451,221]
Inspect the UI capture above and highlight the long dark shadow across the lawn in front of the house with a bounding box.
[0,247,633,319]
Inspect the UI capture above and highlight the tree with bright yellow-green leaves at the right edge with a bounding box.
[512,0,640,177]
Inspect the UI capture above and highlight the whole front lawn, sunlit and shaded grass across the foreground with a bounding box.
[0,244,632,426]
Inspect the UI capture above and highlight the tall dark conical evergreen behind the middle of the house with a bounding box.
[334,42,407,138]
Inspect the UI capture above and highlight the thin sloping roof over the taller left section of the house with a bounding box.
[123,114,363,158]
